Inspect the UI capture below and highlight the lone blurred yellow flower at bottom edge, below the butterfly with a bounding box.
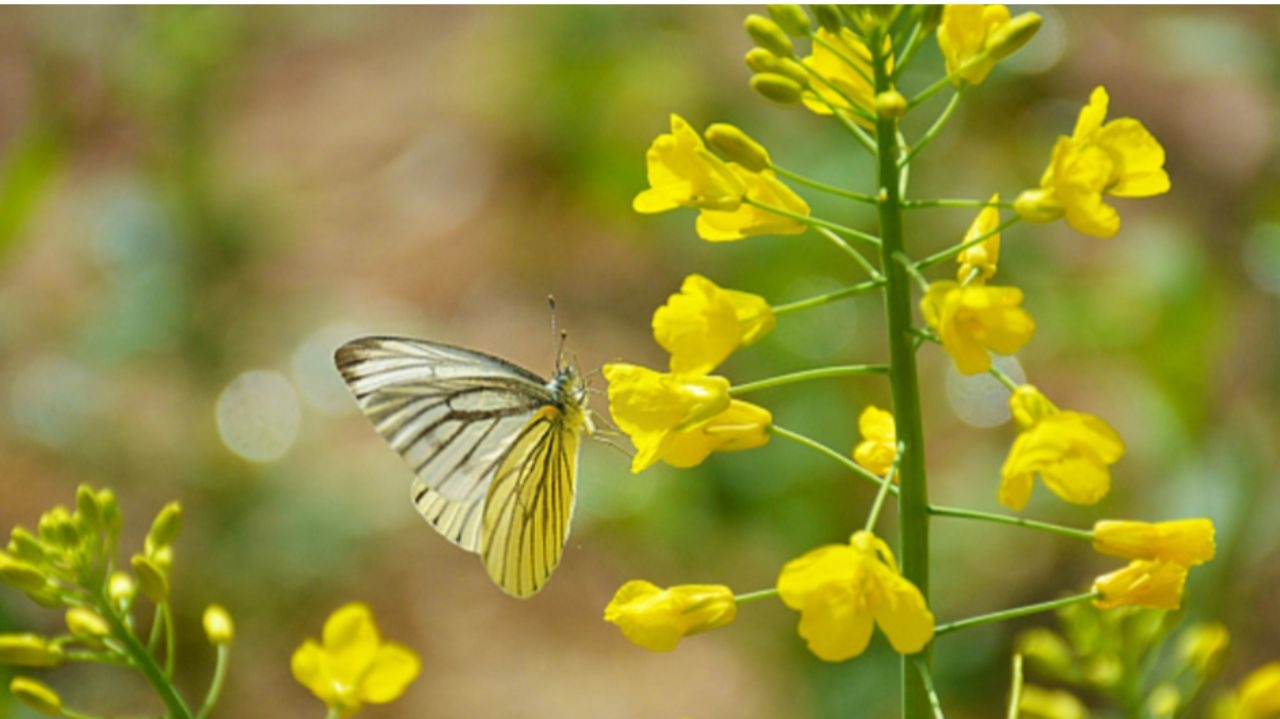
[293,603,421,716]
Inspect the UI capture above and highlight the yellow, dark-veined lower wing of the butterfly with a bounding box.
[480,406,585,599]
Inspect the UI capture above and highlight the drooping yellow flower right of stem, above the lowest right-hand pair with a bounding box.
[998,385,1124,509]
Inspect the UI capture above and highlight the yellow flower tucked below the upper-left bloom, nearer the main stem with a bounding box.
[696,162,809,242]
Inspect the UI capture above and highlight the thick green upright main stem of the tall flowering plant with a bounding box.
[868,27,932,719]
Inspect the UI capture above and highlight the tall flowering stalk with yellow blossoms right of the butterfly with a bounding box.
[604,5,1239,719]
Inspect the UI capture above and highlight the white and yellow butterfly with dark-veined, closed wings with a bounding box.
[334,336,594,599]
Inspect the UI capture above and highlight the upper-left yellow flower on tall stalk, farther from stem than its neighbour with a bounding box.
[631,114,746,214]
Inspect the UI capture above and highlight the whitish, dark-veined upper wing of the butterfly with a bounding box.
[334,338,556,542]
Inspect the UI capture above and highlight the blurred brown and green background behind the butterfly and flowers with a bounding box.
[0,6,1280,719]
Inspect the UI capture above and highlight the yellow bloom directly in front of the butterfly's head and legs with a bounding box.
[604,362,773,472]
